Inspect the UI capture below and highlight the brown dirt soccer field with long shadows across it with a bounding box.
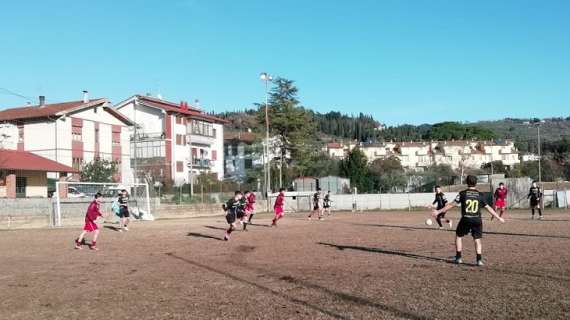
[0,211,570,320]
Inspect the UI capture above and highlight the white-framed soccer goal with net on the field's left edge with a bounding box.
[50,181,154,227]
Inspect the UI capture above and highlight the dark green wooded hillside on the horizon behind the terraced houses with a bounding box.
[217,109,570,148]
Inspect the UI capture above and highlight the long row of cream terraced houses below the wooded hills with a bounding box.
[327,140,520,170]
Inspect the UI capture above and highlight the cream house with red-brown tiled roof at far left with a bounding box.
[0,91,132,183]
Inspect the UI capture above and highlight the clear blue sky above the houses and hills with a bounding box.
[0,0,570,125]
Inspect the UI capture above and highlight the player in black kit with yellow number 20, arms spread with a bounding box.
[433,175,505,266]
